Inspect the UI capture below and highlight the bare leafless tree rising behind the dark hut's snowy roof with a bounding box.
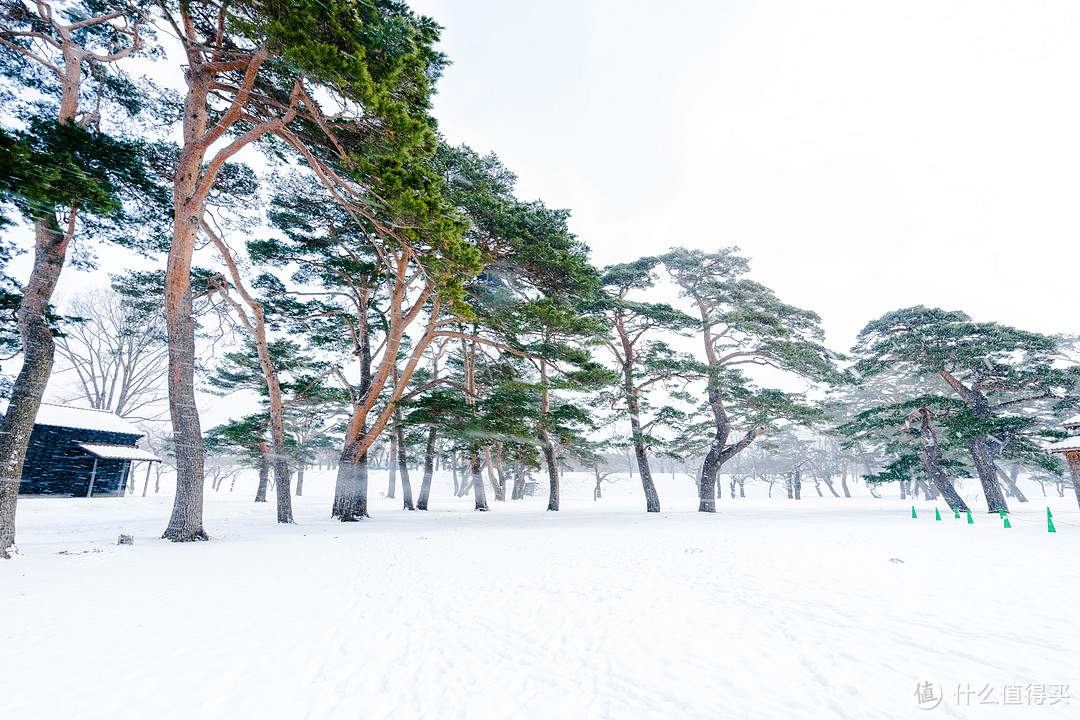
[56,289,168,420]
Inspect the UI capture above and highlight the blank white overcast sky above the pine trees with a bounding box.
[410,0,1080,351]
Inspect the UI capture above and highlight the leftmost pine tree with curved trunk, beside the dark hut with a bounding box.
[0,0,159,557]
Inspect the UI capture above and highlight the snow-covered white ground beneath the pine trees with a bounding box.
[0,473,1080,720]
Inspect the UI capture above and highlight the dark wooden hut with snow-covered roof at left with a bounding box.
[0,403,160,498]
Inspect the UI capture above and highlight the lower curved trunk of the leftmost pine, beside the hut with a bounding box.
[0,220,75,558]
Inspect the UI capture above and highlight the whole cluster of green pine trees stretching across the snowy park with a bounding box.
[0,0,1080,555]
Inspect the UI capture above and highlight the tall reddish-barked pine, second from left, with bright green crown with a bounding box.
[160,0,442,541]
